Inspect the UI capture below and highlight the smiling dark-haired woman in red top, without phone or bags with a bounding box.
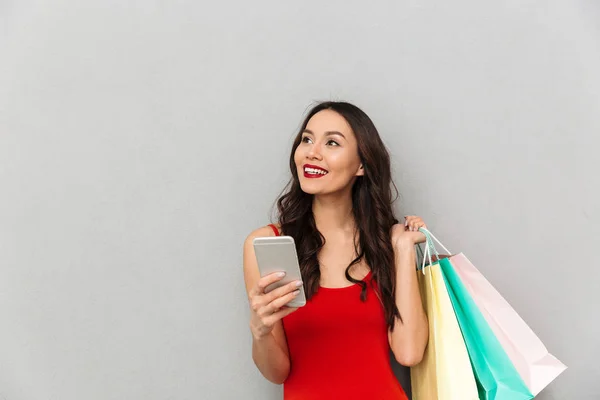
[244,102,429,400]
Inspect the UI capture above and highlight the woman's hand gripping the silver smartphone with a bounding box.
[248,272,302,340]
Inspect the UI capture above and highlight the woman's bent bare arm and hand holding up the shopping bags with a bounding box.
[388,217,429,367]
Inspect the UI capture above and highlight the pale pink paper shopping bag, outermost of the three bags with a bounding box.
[450,254,567,395]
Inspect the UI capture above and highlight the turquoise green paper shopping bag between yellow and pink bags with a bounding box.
[423,231,534,400]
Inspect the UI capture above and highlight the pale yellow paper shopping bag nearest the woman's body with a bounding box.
[410,248,479,400]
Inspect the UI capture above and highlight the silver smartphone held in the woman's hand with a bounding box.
[253,236,306,307]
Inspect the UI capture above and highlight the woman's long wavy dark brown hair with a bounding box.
[277,102,401,329]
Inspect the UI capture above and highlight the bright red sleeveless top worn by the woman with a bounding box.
[275,223,408,400]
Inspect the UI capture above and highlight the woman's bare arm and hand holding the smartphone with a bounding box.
[244,227,297,384]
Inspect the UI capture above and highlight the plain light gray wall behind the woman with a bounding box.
[0,0,600,400]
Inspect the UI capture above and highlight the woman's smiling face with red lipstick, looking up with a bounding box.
[294,110,364,194]
